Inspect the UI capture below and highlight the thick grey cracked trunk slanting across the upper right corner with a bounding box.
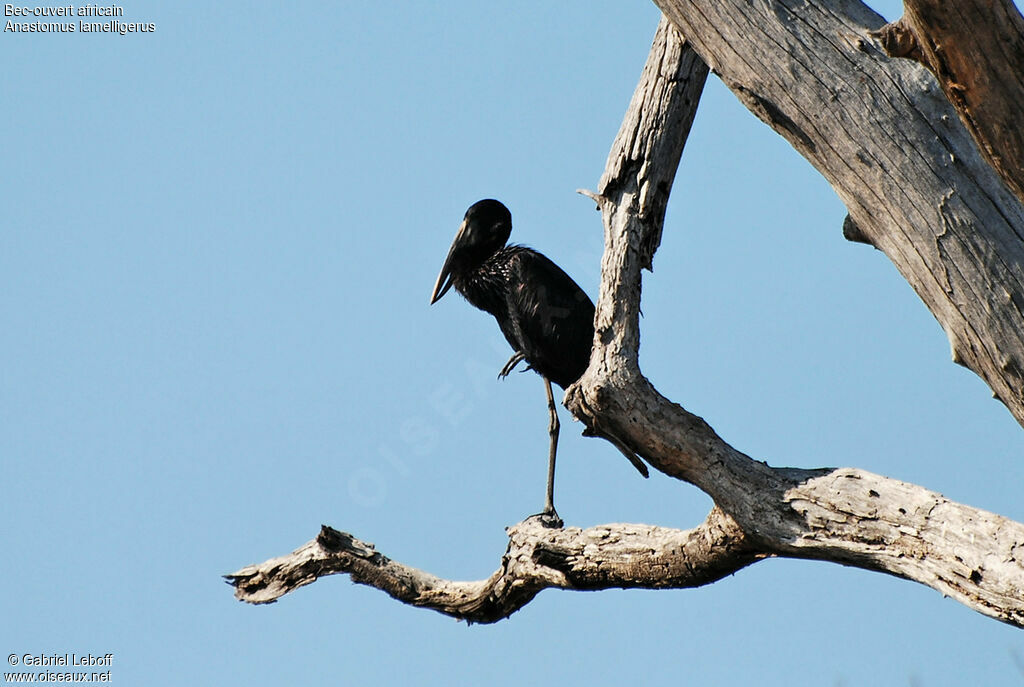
[655,0,1024,425]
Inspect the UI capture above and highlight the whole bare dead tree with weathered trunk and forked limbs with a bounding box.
[228,0,1024,627]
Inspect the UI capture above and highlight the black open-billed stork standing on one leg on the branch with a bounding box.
[430,200,647,521]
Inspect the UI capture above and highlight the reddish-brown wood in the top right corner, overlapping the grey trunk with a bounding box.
[880,0,1024,199]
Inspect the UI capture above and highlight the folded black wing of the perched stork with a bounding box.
[506,249,594,388]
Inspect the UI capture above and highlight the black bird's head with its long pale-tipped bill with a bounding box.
[430,199,512,305]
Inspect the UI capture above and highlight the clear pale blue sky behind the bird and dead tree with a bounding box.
[0,0,1024,687]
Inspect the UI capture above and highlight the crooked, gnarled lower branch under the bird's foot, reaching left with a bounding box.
[225,509,762,622]
